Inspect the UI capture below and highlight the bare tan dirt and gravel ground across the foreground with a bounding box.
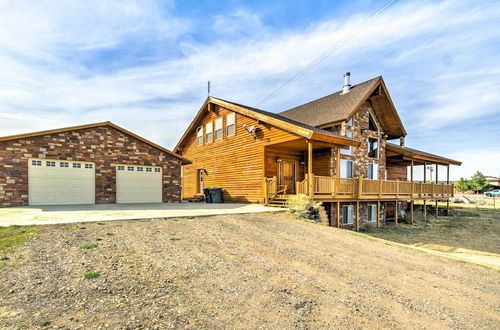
[0,214,500,329]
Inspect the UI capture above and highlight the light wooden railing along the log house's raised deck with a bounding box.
[265,174,453,202]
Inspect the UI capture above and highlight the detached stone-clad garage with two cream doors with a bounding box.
[0,122,189,207]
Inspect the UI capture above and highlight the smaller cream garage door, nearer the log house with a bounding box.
[116,165,162,203]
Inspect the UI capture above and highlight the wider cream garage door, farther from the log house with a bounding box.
[28,159,95,205]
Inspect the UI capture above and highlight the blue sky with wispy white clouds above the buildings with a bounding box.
[0,0,500,179]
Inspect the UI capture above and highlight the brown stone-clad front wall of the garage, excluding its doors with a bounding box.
[0,126,181,207]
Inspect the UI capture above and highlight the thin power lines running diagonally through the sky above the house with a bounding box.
[255,0,399,107]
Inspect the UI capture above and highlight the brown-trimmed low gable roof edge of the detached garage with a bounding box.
[0,121,191,164]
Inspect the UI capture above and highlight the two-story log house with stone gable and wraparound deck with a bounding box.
[174,73,461,230]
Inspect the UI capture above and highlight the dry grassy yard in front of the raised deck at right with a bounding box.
[366,209,500,253]
